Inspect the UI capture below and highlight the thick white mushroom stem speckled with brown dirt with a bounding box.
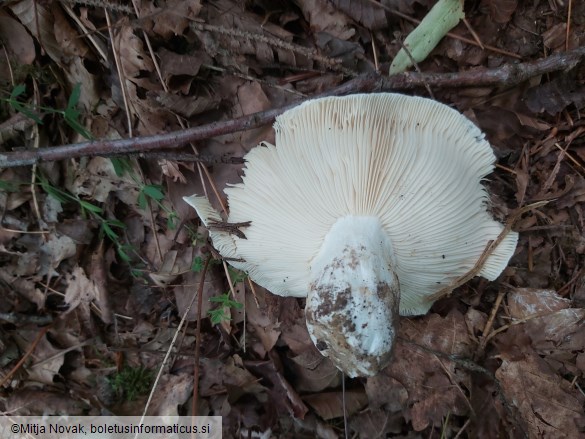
[305,215,400,377]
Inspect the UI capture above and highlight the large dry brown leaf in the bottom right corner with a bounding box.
[496,353,585,439]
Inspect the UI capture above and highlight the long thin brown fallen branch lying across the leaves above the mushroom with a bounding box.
[0,47,585,168]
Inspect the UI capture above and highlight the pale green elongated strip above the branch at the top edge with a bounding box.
[390,0,465,75]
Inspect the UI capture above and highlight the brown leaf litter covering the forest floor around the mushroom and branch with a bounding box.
[0,0,585,438]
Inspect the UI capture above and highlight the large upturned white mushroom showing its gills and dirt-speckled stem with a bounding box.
[184,93,518,377]
